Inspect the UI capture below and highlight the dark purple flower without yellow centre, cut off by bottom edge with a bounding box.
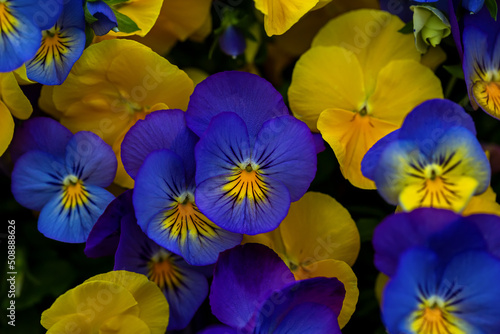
[209,244,345,334]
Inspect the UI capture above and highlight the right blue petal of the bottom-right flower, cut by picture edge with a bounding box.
[440,251,500,333]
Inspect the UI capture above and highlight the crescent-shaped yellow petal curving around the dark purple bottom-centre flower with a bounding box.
[294,260,359,328]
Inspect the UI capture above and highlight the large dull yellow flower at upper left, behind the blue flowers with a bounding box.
[41,39,193,188]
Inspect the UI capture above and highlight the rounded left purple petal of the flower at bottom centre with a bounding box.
[209,244,295,331]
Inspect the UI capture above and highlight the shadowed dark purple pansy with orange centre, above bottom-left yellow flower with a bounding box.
[85,190,211,330]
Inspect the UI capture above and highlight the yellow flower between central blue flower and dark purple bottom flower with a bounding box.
[243,192,360,328]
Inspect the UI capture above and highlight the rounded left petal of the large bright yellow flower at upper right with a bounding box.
[288,47,365,131]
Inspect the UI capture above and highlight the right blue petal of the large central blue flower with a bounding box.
[252,116,316,202]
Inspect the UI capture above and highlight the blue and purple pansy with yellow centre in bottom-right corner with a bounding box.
[373,208,500,334]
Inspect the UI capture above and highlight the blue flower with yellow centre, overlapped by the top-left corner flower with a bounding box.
[26,0,85,85]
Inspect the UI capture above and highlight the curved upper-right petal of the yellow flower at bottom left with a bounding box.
[85,270,169,334]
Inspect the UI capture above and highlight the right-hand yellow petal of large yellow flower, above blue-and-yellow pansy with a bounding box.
[366,60,443,126]
